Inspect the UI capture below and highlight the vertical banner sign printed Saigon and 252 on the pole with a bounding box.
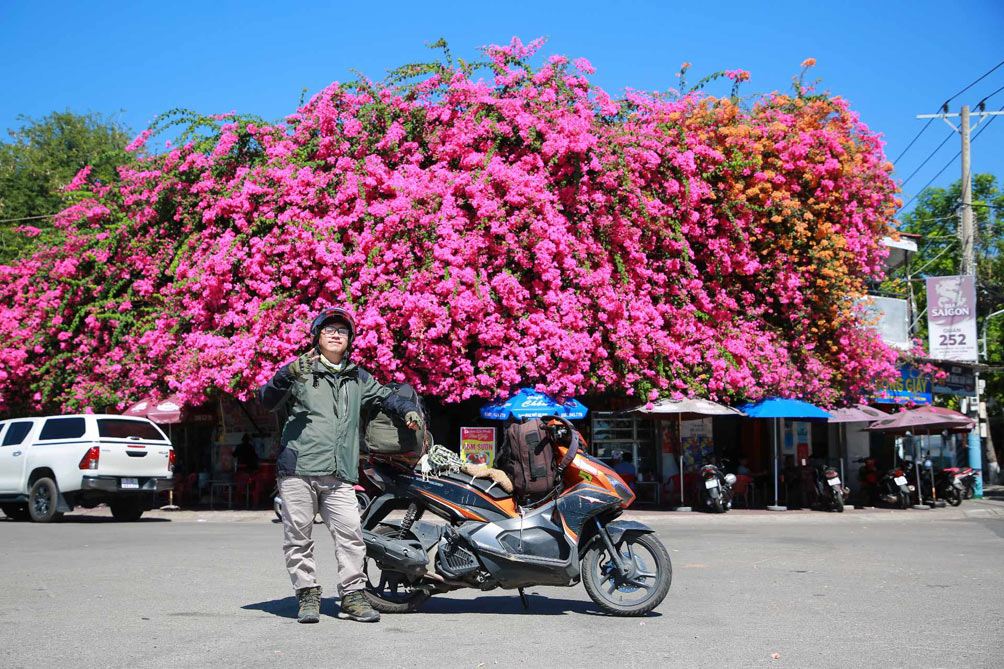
[928,276,977,363]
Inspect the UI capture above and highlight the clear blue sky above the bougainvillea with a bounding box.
[0,0,1004,214]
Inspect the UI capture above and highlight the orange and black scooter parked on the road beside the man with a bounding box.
[362,421,673,616]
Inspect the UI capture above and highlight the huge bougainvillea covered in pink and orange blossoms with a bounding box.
[0,39,897,410]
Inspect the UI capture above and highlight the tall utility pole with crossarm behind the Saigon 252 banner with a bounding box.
[917,102,1004,490]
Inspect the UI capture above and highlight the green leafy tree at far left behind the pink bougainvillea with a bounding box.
[0,110,132,263]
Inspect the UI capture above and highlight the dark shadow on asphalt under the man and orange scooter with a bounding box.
[241,595,662,619]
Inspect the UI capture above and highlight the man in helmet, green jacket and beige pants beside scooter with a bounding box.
[259,308,422,623]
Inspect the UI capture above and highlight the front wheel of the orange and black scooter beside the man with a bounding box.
[582,533,673,616]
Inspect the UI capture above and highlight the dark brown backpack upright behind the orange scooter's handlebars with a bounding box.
[496,418,557,502]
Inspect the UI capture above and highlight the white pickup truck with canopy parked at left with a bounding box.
[0,414,175,522]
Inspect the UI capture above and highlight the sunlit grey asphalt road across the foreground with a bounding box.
[0,502,1004,669]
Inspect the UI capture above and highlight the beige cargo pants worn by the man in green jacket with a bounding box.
[279,476,366,597]
